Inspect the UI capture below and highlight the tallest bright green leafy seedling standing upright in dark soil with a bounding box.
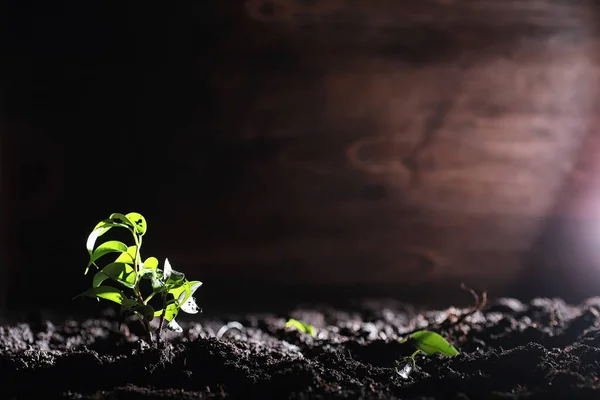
[76,212,202,344]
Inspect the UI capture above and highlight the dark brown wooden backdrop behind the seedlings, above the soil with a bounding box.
[0,0,600,309]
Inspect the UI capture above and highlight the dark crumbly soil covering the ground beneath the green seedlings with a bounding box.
[0,298,600,400]
